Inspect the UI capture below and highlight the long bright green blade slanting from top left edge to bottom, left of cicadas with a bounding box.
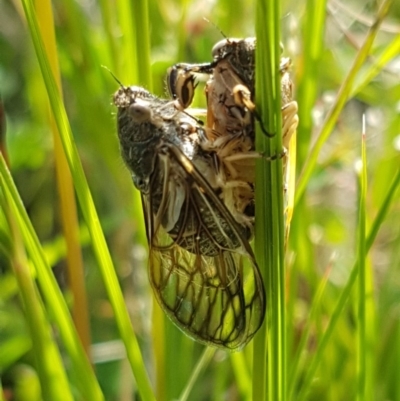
[19,0,154,400]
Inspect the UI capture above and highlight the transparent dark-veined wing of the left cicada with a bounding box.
[143,146,265,349]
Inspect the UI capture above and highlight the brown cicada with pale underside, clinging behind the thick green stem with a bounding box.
[167,38,298,234]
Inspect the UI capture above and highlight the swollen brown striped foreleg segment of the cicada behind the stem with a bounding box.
[167,67,196,109]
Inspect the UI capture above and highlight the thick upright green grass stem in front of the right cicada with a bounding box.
[253,0,286,400]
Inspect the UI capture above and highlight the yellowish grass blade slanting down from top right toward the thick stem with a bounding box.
[295,0,393,204]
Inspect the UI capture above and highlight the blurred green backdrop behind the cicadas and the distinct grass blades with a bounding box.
[0,0,400,401]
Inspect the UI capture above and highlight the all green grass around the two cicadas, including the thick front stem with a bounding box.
[0,0,400,401]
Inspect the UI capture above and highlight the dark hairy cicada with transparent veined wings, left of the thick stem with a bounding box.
[114,85,266,350]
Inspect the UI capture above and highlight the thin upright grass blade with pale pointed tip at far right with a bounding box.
[357,116,368,401]
